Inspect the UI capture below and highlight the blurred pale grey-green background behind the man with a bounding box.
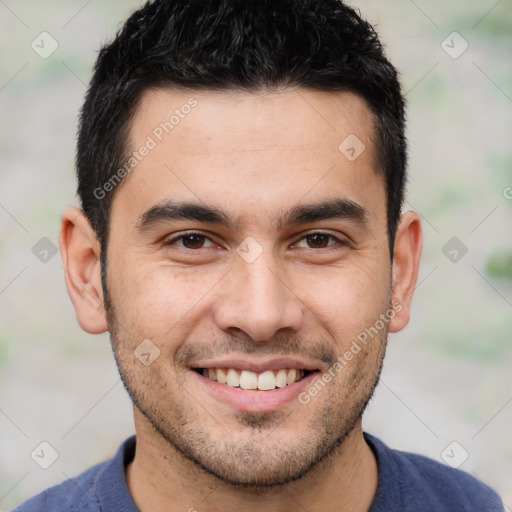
[0,0,512,510]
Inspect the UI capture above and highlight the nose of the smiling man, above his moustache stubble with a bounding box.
[214,254,304,342]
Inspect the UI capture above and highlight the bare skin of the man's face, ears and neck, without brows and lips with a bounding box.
[60,89,422,512]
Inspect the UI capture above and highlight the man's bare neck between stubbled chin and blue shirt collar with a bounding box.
[126,411,378,512]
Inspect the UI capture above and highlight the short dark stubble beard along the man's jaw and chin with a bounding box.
[104,284,387,492]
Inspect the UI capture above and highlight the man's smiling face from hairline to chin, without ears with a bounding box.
[107,89,392,485]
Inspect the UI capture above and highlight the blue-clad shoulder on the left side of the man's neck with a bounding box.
[12,437,135,512]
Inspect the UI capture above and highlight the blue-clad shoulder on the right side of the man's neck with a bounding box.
[364,433,504,512]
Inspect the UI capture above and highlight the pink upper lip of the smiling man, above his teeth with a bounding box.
[191,357,319,373]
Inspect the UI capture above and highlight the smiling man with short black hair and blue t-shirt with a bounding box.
[16,0,503,512]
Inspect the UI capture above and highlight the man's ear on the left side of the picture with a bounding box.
[59,206,108,334]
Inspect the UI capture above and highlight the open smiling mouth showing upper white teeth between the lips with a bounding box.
[192,368,317,391]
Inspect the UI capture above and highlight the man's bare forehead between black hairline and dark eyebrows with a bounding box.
[113,89,385,230]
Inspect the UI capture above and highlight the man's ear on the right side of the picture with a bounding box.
[389,211,423,332]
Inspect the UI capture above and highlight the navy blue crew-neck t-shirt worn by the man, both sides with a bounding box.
[13,433,504,512]
